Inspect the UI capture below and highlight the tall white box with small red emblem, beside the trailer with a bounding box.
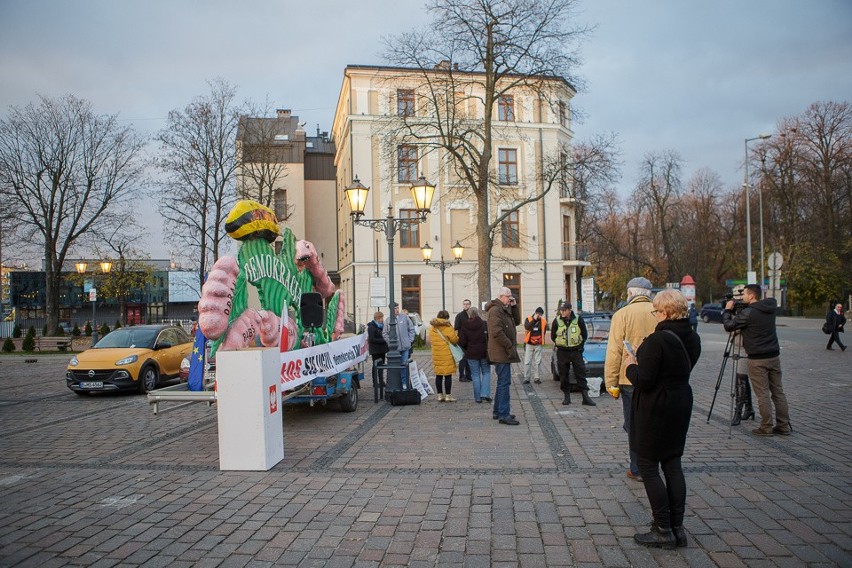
[216,348,284,471]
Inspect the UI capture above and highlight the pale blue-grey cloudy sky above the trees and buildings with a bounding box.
[0,0,852,258]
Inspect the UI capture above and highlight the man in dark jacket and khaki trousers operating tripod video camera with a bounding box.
[722,284,793,436]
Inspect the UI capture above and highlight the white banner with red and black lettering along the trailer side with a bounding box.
[281,333,367,391]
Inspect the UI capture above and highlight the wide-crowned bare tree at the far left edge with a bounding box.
[0,95,142,329]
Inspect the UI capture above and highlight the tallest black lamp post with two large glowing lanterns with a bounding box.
[343,175,435,396]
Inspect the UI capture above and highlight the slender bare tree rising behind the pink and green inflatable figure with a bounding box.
[155,79,240,286]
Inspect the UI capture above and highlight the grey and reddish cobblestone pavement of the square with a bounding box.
[0,319,852,568]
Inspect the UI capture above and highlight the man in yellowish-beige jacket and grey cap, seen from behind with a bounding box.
[604,276,657,481]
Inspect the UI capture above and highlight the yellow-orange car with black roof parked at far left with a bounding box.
[65,325,192,395]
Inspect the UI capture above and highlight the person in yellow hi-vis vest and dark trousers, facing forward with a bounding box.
[550,302,597,406]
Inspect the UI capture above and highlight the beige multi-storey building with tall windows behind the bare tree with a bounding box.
[327,65,589,323]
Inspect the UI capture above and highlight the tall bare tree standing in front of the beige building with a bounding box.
[386,0,586,300]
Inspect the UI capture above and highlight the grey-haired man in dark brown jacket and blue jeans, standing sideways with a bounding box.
[485,286,521,426]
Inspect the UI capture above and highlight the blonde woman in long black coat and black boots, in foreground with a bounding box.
[624,290,701,548]
